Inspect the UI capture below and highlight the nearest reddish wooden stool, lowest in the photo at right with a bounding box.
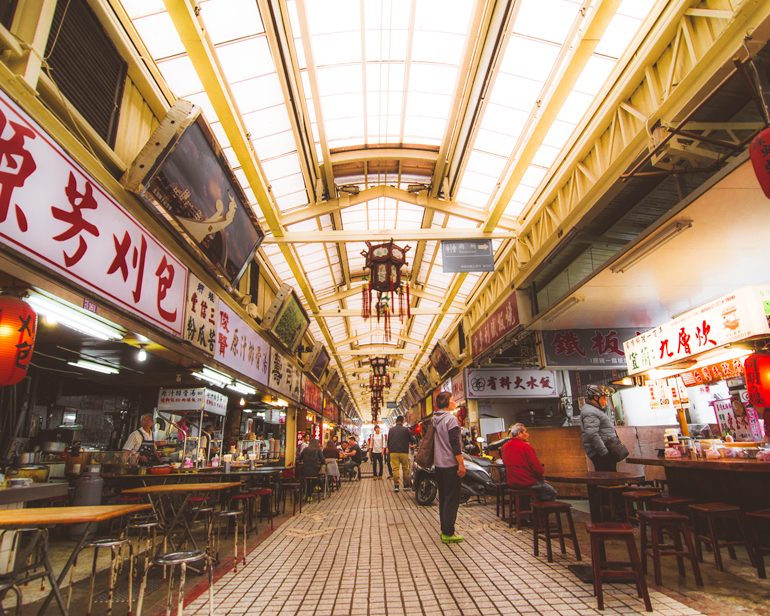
[586,522,652,612]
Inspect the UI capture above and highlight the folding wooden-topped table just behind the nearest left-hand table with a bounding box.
[123,481,241,555]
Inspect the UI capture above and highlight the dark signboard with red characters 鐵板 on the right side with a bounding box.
[542,328,639,368]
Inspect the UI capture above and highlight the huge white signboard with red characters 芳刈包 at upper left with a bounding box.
[0,92,187,336]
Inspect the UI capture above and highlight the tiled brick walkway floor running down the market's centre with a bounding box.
[185,479,712,616]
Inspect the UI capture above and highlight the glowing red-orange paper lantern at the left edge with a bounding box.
[0,295,37,385]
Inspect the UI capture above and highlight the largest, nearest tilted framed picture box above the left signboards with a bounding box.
[124,100,265,285]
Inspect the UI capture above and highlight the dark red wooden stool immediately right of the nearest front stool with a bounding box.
[638,510,703,586]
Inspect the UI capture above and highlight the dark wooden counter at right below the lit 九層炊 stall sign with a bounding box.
[628,457,770,511]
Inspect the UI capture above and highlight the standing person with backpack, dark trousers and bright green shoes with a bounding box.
[433,391,465,543]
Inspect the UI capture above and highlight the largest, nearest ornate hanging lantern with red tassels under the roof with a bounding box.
[361,240,412,341]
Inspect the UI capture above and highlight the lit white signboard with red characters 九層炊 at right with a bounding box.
[623,287,770,374]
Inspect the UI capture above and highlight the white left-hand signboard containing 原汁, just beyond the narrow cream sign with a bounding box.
[214,302,270,385]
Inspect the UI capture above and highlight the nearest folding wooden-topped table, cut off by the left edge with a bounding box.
[0,506,150,616]
